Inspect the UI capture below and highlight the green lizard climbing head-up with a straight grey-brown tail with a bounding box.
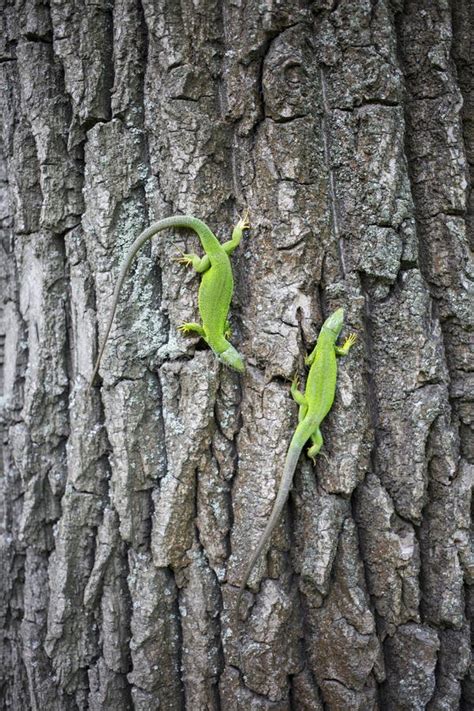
[236,309,356,611]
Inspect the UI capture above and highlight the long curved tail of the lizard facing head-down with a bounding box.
[89,215,218,389]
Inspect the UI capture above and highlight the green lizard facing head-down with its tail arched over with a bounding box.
[90,211,250,387]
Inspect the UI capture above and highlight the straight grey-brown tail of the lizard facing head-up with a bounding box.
[235,434,309,612]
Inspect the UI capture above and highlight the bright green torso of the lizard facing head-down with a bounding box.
[198,253,234,339]
